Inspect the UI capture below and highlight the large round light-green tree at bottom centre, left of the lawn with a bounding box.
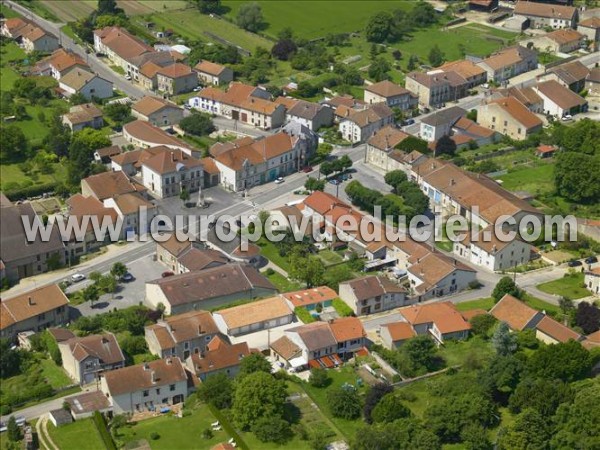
[231,371,287,430]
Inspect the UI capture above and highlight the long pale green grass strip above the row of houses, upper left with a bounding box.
[145,10,273,52]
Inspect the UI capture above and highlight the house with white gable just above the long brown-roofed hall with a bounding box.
[156,234,229,274]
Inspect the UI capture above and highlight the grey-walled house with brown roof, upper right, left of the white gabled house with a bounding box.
[477,46,538,83]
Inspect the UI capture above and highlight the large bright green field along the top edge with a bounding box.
[223,0,412,39]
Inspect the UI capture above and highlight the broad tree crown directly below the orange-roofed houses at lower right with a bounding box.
[527,340,593,382]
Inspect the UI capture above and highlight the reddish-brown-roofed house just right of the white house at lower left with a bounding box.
[185,336,251,381]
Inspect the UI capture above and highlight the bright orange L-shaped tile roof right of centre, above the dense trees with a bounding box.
[398,302,471,334]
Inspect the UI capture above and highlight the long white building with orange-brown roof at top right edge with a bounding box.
[513,0,578,29]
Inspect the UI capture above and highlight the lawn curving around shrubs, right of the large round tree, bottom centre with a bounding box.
[302,366,367,440]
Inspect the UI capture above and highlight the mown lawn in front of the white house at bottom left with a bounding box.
[118,405,229,450]
